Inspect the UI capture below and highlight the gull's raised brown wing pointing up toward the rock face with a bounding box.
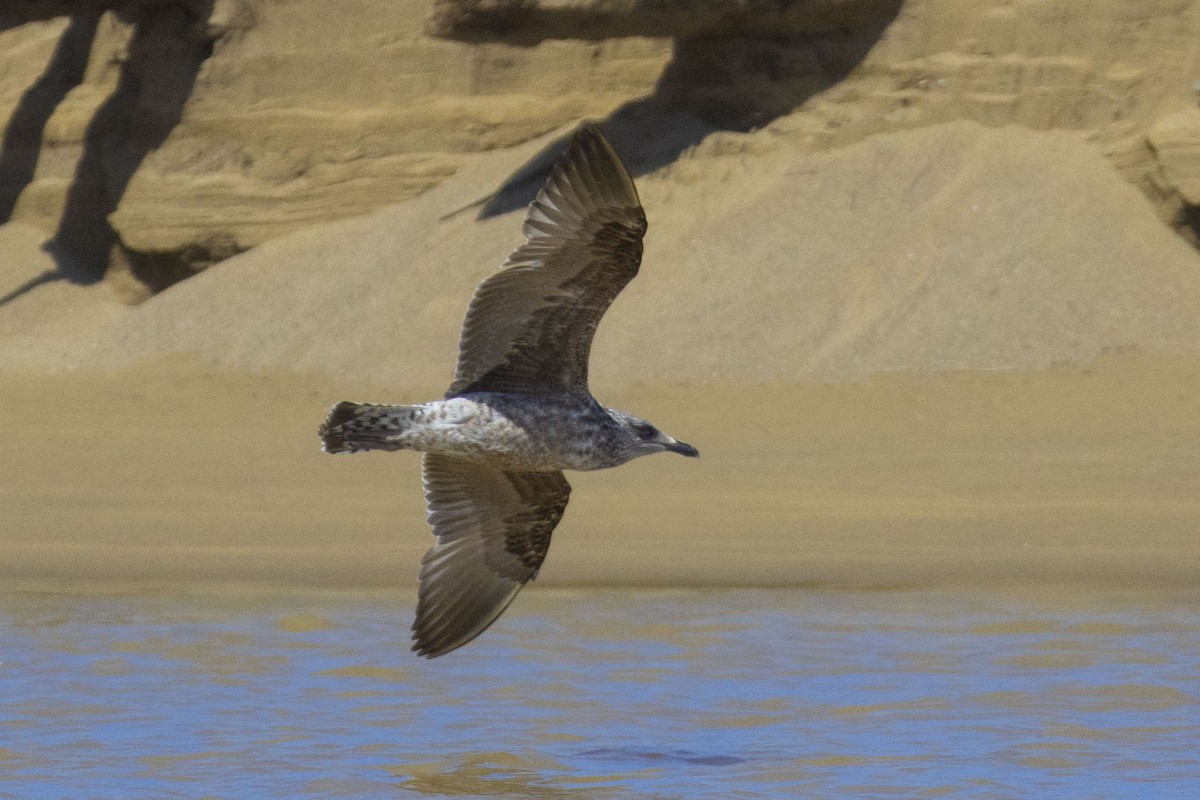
[446,124,646,397]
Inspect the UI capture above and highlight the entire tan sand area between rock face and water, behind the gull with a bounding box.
[0,124,1200,588]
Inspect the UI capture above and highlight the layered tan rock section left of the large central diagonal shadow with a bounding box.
[0,0,671,297]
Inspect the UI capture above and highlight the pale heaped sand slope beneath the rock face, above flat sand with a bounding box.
[0,124,1200,389]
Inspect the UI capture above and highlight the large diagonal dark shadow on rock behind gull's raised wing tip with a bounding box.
[479,0,902,219]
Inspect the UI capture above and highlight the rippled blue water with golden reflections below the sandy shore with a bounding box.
[0,589,1200,799]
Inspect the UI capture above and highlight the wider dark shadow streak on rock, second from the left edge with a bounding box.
[47,0,212,284]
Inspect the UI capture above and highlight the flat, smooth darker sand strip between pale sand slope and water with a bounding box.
[0,355,1200,590]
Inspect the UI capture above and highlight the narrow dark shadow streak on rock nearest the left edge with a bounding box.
[0,13,100,224]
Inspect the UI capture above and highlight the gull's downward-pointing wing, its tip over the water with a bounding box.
[413,453,571,658]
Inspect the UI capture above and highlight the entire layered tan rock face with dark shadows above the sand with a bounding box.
[0,0,1200,299]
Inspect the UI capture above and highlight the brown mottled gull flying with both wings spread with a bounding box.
[320,124,698,658]
